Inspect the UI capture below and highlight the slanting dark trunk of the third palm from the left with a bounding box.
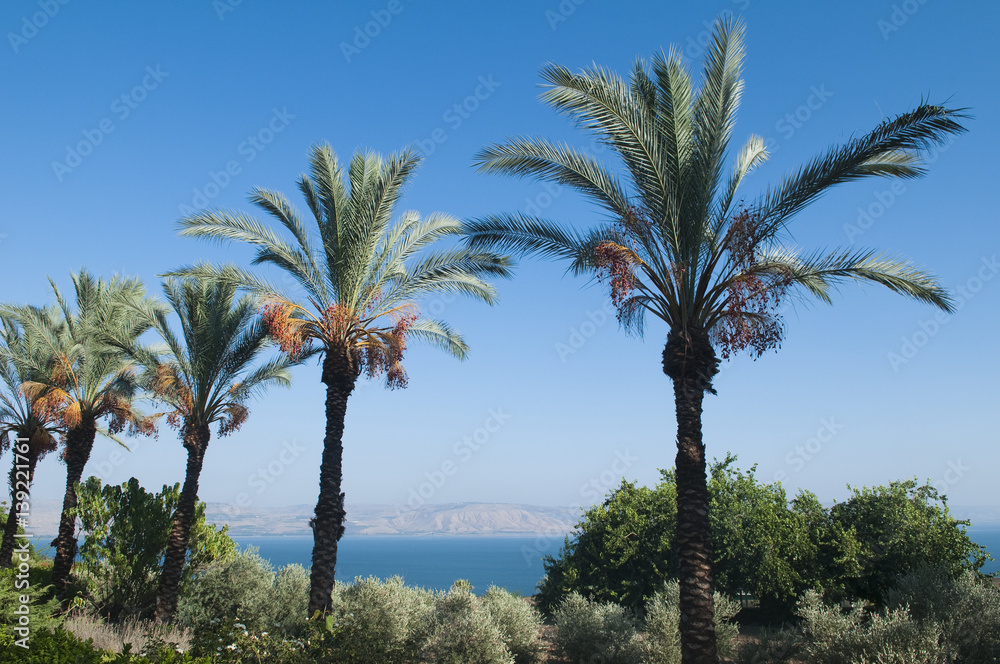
[156,425,212,623]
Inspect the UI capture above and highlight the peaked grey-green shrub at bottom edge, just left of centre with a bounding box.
[422,583,514,664]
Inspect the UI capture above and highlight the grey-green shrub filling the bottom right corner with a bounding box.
[886,567,1000,664]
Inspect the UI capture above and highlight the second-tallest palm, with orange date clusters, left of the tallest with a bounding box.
[174,145,509,615]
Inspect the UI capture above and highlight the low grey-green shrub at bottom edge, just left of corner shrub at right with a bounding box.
[798,591,940,664]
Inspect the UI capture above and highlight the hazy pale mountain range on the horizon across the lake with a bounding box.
[15,500,1000,536]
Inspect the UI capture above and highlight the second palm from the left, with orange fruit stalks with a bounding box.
[3,270,156,597]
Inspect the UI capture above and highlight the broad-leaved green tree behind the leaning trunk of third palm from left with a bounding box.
[75,477,236,621]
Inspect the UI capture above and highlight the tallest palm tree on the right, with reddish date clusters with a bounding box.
[466,18,965,663]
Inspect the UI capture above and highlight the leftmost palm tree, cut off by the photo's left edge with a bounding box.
[0,309,65,567]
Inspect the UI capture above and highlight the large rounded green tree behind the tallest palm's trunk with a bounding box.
[539,455,808,613]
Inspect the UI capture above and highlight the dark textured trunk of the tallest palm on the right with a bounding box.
[663,330,719,664]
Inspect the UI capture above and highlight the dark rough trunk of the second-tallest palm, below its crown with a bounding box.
[309,351,358,617]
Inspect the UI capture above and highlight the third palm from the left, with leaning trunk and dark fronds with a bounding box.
[122,279,291,622]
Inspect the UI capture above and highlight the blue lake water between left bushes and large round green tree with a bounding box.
[233,535,562,595]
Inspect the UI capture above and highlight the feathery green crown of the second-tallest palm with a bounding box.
[168,145,510,384]
